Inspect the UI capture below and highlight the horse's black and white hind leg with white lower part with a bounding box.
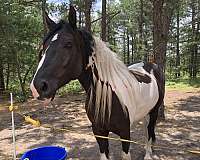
[144,107,158,160]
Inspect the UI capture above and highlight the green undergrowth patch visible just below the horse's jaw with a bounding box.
[58,80,83,96]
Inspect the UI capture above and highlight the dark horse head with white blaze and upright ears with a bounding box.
[31,6,86,103]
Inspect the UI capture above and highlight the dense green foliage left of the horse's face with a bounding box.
[0,0,43,100]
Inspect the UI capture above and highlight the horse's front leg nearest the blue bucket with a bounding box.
[92,127,109,160]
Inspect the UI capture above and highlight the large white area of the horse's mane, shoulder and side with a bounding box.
[90,37,159,125]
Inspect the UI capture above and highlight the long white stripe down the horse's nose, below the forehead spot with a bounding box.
[30,46,49,98]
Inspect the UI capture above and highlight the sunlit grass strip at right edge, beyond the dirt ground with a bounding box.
[166,78,200,90]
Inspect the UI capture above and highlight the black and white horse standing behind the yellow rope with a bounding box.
[31,6,164,160]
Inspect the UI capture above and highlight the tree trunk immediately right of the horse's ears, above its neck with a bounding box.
[85,0,92,32]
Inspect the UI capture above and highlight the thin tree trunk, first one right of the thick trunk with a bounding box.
[176,6,180,78]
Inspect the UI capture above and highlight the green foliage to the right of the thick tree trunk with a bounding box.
[166,0,200,79]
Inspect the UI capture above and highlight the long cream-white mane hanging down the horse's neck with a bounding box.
[89,37,137,122]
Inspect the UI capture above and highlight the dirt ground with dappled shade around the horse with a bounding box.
[0,90,200,160]
